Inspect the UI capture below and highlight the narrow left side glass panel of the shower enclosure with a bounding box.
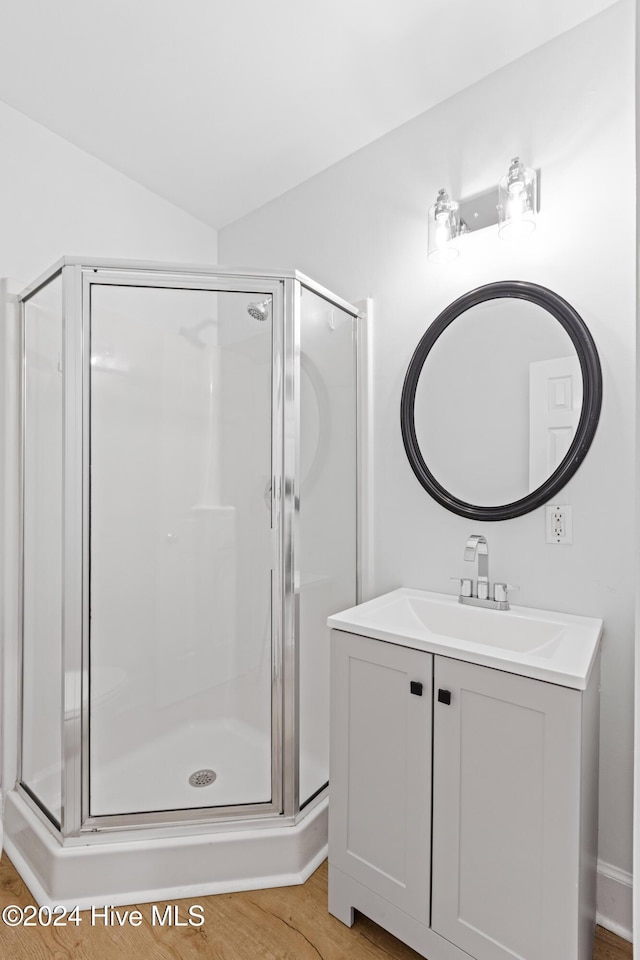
[21,275,63,822]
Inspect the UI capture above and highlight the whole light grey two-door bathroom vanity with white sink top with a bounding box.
[329,589,602,960]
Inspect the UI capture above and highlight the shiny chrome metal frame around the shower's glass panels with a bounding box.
[16,257,365,845]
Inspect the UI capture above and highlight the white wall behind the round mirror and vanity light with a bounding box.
[219,0,635,927]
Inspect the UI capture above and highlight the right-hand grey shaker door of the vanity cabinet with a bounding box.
[431,656,581,960]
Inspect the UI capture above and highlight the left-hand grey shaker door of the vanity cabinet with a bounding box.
[329,630,433,924]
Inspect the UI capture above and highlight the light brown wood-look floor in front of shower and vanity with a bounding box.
[0,854,632,960]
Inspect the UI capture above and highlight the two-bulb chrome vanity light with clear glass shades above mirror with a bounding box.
[428,157,539,263]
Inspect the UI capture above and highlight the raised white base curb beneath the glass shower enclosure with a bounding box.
[4,791,328,910]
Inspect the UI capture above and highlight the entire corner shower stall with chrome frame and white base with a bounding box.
[5,257,359,905]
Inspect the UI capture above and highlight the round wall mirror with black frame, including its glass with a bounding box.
[401,281,602,520]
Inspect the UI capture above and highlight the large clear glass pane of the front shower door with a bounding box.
[85,281,273,817]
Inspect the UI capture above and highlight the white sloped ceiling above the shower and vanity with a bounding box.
[0,0,614,227]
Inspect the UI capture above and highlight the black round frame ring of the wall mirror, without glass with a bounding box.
[400,280,602,520]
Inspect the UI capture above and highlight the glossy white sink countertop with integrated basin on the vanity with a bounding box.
[328,588,602,689]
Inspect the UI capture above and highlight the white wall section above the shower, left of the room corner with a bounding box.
[0,102,217,283]
